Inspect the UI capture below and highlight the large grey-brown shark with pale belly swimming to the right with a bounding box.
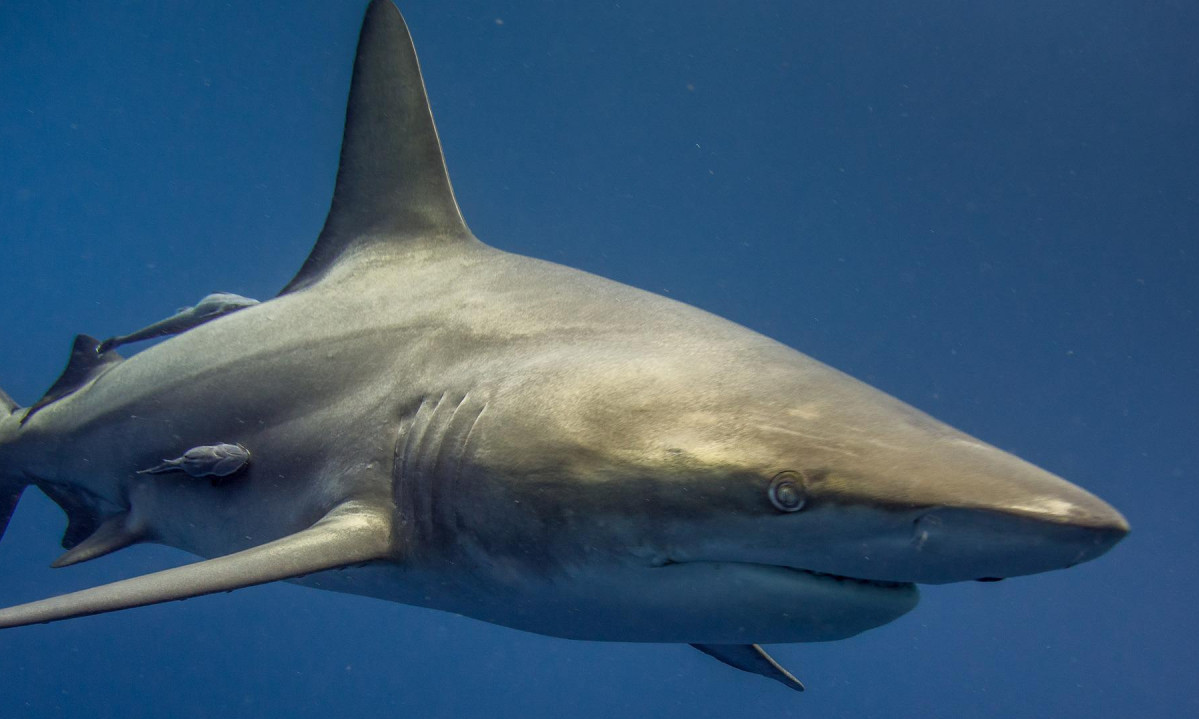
[0,0,1129,689]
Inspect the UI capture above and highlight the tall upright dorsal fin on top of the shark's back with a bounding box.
[283,0,472,294]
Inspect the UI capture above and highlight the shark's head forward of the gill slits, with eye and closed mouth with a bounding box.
[446,300,1128,642]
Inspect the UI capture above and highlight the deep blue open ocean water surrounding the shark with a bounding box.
[0,0,1199,719]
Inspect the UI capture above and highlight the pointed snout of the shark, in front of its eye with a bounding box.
[767,431,1128,584]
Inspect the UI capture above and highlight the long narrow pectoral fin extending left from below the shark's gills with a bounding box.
[0,502,392,628]
